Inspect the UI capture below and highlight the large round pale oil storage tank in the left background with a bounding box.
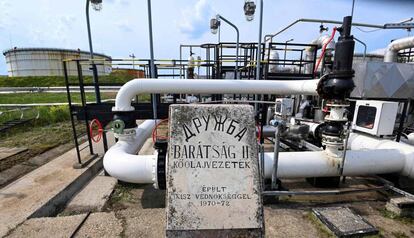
[3,47,112,77]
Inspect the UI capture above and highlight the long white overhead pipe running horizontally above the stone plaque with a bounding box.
[112,79,319,112]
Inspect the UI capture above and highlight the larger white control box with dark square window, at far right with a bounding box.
[352,100,398,136]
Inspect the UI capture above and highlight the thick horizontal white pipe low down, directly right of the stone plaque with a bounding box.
[265,149,406,178]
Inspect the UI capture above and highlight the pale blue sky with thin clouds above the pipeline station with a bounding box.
[0,0,414,75]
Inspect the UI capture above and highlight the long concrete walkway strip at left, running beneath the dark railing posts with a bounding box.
[0,140,102,237]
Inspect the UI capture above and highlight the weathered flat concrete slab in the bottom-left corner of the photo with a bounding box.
[8,214,86,238]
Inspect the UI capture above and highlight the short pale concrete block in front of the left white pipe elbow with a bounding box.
[63,175,118,214]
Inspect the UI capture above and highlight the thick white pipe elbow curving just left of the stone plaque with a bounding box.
[103,120,156,184]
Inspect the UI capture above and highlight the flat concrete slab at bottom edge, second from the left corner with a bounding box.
[75,212,123,237]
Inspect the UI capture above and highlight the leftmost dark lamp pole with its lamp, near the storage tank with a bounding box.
[85,0,102,103]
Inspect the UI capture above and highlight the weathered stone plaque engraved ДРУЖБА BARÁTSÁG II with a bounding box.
[166,105,264,237]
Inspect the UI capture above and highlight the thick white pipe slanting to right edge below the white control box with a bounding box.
[347,133,414,178]
